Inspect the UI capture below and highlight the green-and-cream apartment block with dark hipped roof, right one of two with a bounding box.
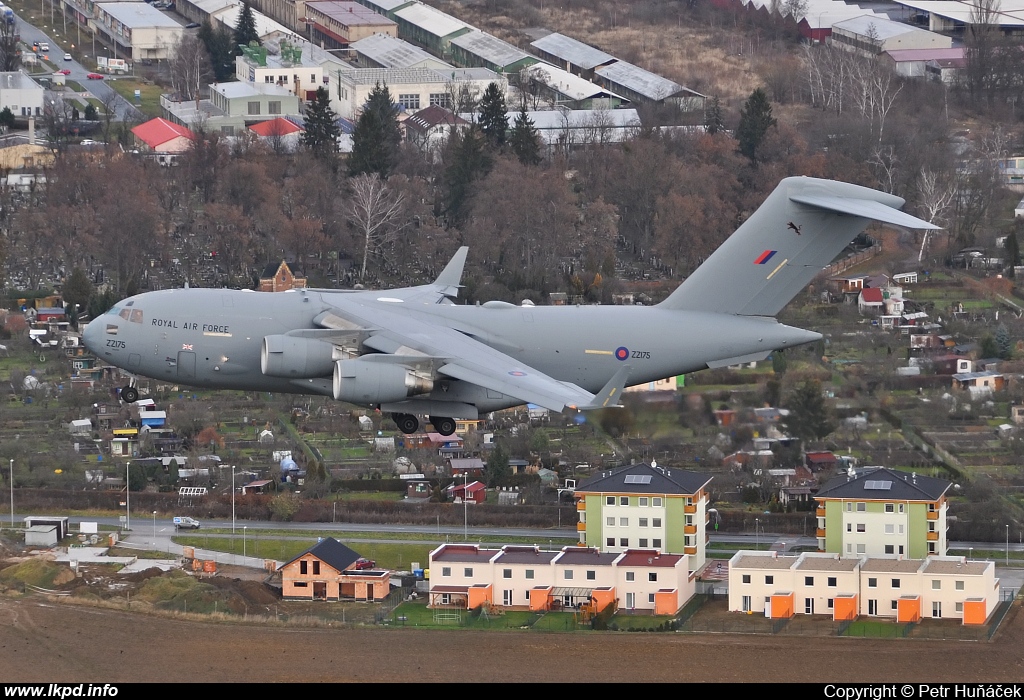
[814,468,951,559]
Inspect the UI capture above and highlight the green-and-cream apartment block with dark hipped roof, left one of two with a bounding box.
[573,462,712,571]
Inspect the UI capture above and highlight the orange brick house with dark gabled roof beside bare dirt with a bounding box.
[279,537,391,601]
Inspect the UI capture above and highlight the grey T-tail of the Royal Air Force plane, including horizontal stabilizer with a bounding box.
[658,177,938,316]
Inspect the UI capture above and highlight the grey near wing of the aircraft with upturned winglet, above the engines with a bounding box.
[336,304,630,411]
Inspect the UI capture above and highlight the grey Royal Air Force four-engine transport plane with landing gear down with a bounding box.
[84,177,937,435]
